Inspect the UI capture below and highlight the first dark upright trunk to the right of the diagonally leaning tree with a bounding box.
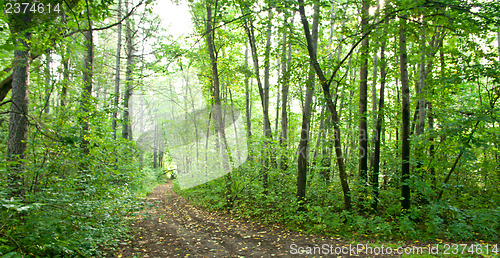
[358,0,370,185]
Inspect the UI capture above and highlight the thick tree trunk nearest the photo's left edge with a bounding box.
[7,12,32,198]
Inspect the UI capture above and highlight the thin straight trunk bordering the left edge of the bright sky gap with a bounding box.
[122,2,134,140]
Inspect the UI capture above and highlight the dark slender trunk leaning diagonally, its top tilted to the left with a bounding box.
[298,0,351,210]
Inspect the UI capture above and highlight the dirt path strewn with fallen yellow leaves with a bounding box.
[115,182,352,257]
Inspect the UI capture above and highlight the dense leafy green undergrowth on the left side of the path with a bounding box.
[0,140,160,257]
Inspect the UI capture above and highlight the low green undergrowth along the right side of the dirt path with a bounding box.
[178,162,500,243]
